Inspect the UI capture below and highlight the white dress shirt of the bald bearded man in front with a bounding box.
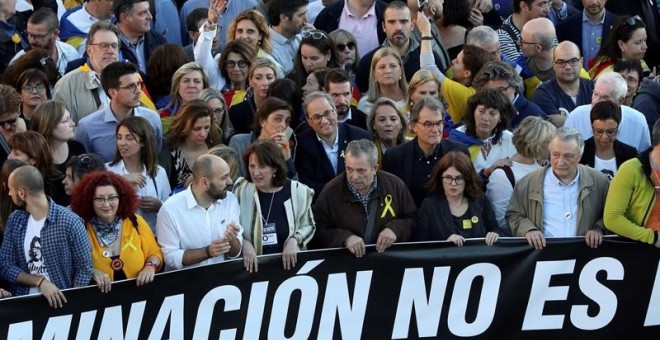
[156,186,243,271]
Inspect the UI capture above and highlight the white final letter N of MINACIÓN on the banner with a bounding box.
[318,270,373,339]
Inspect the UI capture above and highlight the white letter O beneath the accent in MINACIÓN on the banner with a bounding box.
[268,275,319,339]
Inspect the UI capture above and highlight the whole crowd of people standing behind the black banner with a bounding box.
[0,0,660,307]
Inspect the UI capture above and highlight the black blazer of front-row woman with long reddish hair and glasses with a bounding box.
[413,194,502,241]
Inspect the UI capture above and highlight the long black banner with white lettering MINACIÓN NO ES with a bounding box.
[0,238,660,339]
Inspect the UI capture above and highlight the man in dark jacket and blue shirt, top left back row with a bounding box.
[113,0,167,74]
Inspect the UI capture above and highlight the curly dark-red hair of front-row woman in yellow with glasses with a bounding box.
[71,170,138,222]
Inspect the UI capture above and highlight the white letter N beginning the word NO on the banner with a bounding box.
[392,267,450,339]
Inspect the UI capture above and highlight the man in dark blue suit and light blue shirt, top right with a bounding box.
[557,0,616,70]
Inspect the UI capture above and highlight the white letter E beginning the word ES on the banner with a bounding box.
[522,260,575,331]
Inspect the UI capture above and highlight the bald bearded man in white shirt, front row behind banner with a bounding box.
[156,155,243,271]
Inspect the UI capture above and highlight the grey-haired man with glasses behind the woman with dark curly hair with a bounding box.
[473,61,545,129]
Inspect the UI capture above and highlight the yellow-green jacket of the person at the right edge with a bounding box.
[603,149,656,244]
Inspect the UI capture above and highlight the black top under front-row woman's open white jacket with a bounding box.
[257,180,291,254]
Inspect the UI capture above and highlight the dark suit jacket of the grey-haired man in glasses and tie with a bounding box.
[295,123,371,200]
